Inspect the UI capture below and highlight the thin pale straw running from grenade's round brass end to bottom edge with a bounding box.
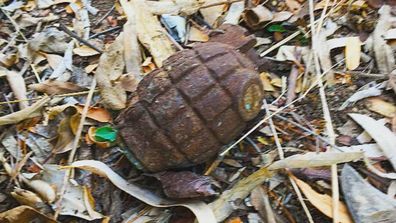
[264,100,314,223]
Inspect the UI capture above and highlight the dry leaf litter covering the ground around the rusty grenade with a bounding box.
[0,0,396,223]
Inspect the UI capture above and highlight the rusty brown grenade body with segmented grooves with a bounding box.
[116,42,263,172]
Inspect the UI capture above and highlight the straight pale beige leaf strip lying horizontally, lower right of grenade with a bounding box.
[268,152,363,170]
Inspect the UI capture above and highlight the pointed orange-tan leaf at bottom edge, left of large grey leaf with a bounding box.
[291,176,353,223]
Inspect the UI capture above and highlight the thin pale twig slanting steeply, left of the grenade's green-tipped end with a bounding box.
[54,78,96,219]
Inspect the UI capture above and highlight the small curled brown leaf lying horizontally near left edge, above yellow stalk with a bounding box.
[29,80,85,95]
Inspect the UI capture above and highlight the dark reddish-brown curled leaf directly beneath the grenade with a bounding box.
[150,171,217,198]
